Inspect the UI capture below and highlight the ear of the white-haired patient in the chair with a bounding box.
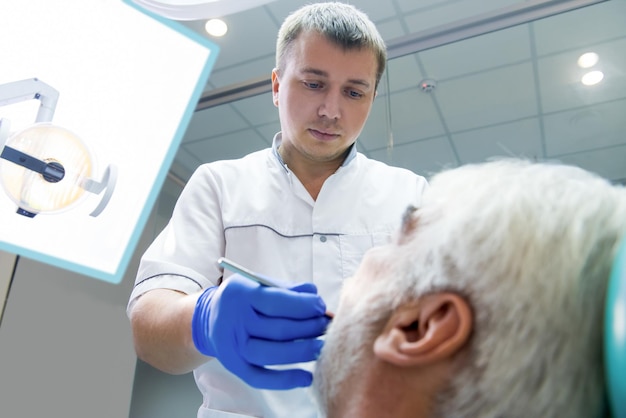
[374,292,473,367]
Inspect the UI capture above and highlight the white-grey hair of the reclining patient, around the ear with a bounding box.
[322,160,626,418]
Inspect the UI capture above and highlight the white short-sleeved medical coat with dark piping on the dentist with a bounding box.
[129,134,428,418]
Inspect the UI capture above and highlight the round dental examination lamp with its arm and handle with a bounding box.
[0,78,117,218]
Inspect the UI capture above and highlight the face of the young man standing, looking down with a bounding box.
[272,32,377,162]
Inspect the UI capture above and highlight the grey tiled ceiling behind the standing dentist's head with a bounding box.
[171,0,626,185]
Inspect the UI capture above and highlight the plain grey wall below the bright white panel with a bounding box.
[0,188,169,418]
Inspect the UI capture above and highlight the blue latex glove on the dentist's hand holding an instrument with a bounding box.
[191,274,330,389]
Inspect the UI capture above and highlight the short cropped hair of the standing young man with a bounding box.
[276,2,387,86]
